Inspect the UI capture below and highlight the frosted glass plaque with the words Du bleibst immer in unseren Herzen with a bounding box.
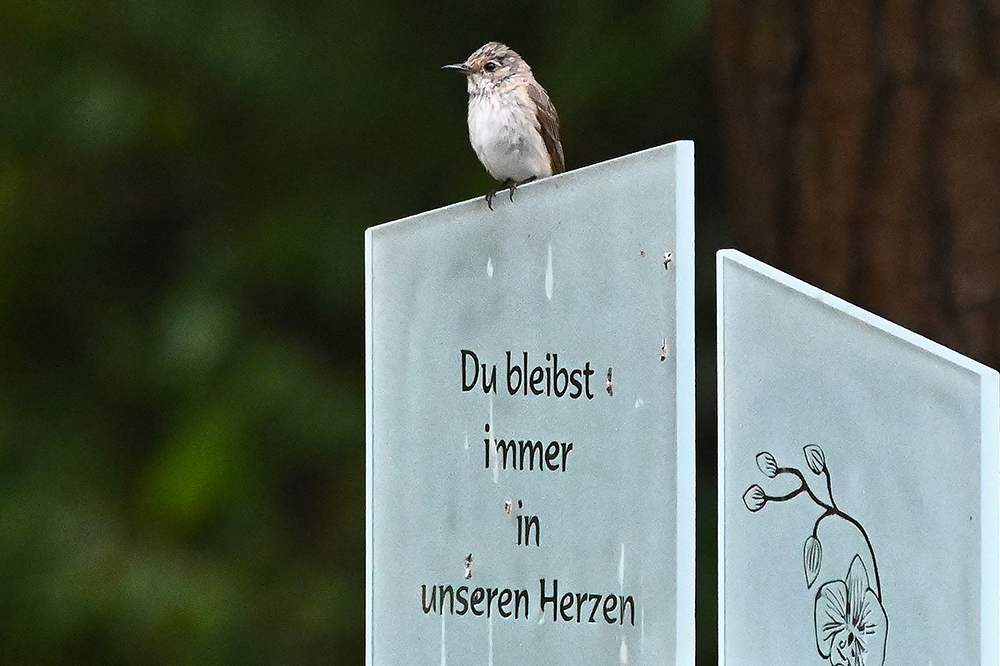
[365,142,694,666]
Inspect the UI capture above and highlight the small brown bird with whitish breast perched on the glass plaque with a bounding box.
[442,42,566,210]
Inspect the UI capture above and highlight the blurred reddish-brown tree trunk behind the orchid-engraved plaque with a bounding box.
[712,0,1000,367]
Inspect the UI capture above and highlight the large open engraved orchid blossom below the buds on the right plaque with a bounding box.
[816,555,888,666]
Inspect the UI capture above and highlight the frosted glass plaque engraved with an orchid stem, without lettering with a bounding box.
[717,250,1000,666]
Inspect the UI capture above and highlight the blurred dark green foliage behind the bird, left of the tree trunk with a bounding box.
[0,0,721,664]
